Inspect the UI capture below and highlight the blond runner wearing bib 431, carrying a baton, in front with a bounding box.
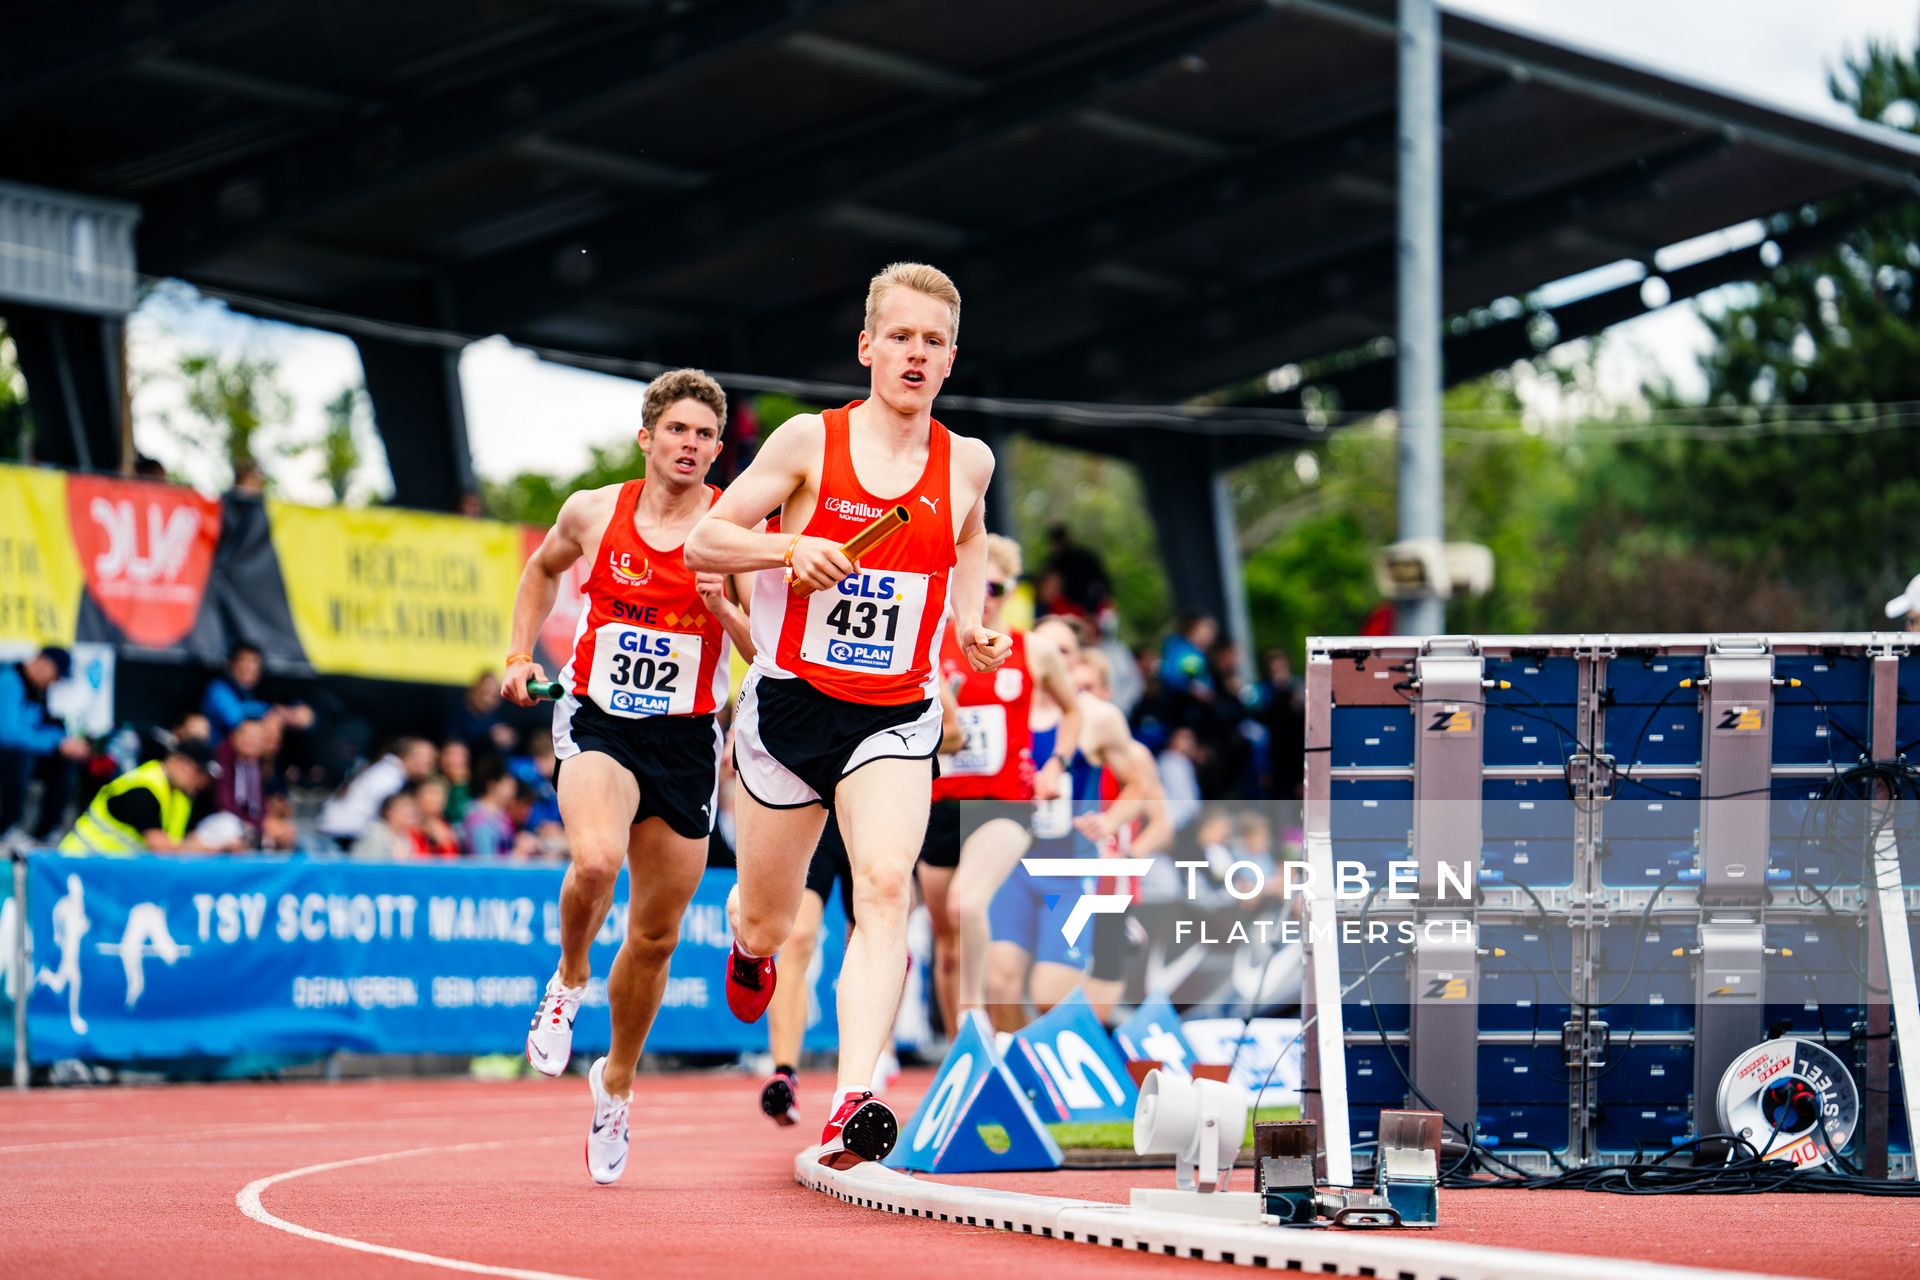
[687,263,1010,1167]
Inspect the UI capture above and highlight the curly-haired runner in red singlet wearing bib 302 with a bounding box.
[501,368,753,1182]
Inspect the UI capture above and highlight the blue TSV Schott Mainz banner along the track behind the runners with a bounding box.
[15,854,847,1063]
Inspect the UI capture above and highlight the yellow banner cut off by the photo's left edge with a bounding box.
[0,466,81,647]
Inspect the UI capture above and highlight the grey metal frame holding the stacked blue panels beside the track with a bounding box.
[1304,631,1920,1180]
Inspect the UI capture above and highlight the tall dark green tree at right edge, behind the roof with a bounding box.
[1603,32,1920,628]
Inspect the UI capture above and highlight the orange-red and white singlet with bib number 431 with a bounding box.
[753,401,954,706]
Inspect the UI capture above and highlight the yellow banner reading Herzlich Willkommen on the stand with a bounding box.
[267,501,526,685]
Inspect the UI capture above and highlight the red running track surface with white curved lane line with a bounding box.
[0,1073,1920,1280]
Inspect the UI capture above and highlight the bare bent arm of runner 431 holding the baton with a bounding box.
[687,413,852,591]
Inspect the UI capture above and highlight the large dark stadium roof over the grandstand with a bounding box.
[0,0,1920,457]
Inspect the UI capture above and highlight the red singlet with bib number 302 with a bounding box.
[561,480,728,720]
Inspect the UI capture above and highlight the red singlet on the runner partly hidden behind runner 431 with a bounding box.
[933,626,1035,800]
